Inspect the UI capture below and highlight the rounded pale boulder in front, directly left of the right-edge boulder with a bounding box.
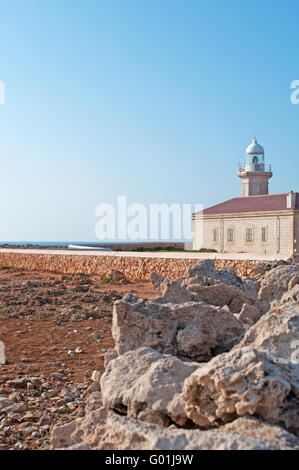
[101,348,199,426]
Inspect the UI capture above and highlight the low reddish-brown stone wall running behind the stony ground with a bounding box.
[0,251,259,281]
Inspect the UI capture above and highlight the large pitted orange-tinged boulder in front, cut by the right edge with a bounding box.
[183,347,299,434]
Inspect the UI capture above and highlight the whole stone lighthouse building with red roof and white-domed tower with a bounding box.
[192,138,299,256]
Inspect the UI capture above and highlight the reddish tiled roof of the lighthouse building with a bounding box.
[197,193,299,215]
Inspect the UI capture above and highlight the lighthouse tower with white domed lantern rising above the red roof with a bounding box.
[238,138,272,197]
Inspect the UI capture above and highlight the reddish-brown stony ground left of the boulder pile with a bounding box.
[0,267,156,449]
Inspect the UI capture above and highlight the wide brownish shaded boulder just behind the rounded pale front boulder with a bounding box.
[112,296,245,362]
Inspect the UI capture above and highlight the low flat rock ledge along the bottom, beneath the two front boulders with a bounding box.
[51,408,298,451]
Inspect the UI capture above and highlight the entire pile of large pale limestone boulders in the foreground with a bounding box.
[51,260,299,450]
